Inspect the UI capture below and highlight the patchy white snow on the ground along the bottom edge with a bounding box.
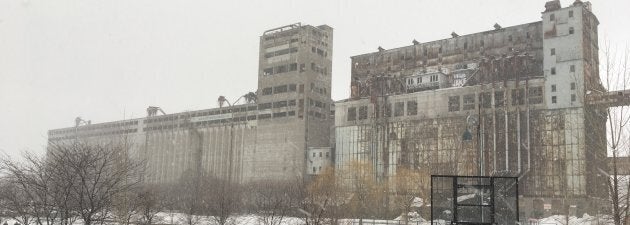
[2,213,614,225]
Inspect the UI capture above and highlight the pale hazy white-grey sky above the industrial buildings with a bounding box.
[0,0,630,155]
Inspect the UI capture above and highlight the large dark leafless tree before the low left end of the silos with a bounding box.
[47,142,141,225]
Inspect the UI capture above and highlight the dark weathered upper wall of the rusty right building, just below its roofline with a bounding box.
[350,22,543,98]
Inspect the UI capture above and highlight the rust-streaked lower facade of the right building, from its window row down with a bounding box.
[335,79,606,216]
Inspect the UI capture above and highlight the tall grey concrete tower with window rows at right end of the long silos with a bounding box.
[245,23,333,180]
